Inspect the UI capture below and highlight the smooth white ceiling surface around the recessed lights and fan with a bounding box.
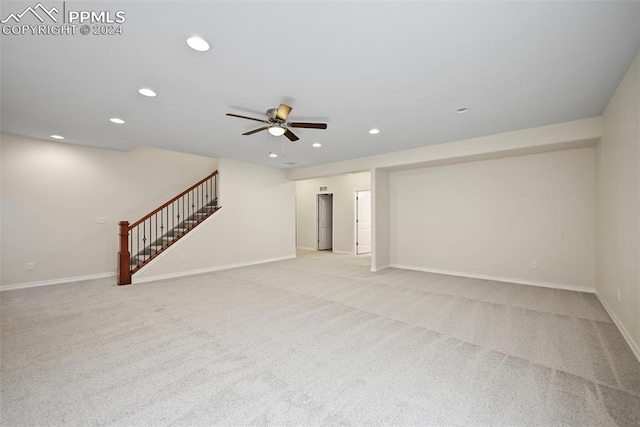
[0,0,640,168]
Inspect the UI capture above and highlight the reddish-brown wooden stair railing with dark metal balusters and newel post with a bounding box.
[118,171,220,285]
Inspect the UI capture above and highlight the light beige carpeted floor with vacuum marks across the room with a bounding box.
[0,252,640,426]
